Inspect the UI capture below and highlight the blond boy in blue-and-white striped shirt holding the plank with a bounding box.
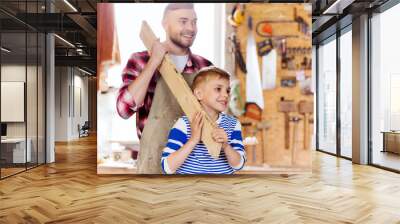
[161,66,246,174]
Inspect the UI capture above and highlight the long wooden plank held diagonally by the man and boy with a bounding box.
[140,21,222,158]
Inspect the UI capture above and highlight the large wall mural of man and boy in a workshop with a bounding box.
[97,3,314,175]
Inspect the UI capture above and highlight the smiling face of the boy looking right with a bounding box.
[194,77,230,112]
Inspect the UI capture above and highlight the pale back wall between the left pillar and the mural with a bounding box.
[55,67,88,141]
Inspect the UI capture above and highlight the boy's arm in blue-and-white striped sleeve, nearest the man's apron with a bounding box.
[161,113,203,174]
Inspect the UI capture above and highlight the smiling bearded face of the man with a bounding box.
[164,9,197,48]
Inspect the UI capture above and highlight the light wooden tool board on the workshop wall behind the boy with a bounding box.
[227,3,314,171]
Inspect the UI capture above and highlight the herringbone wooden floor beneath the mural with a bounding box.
[0,137,400,224]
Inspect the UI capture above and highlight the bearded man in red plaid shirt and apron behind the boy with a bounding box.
[117,3,211,173]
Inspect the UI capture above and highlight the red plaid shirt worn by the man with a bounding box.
[117,51,211,139]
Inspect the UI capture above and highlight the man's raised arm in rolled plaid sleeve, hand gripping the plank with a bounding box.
[117,41,166,119]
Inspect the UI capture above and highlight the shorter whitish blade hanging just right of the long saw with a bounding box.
[261,49,277,90]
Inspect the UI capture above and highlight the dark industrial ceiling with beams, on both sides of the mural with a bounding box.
[0,0,394,74]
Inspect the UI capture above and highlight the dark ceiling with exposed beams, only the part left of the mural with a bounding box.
[0,0,97,74]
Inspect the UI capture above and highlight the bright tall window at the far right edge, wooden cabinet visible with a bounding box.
[370,2,400,170]
